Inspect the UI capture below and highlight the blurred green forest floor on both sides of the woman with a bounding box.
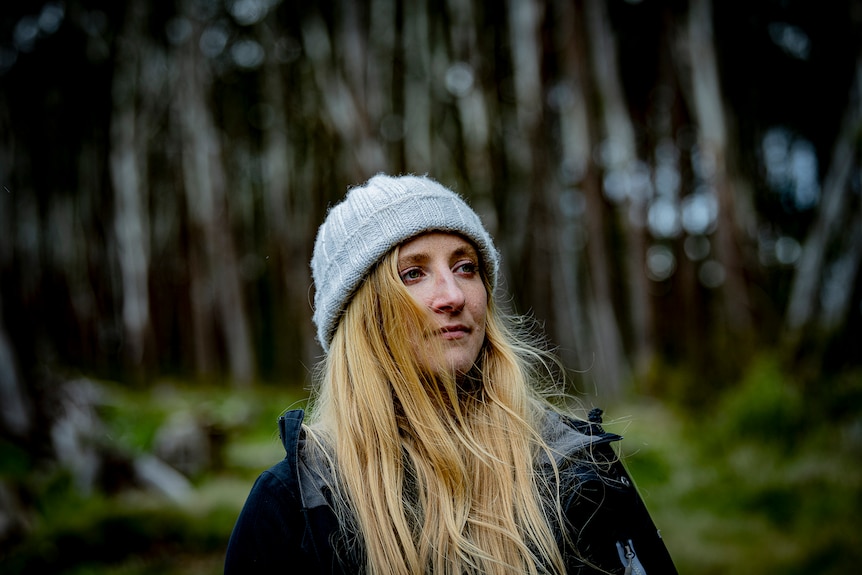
[0,364,862,575]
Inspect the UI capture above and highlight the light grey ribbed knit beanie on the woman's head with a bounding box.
[311,174,500,351]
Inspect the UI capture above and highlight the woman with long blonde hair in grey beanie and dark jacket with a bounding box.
[225,175,676,575]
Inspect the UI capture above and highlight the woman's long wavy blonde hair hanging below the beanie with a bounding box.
[306,248,565,575]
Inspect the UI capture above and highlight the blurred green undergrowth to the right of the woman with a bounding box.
[608,359,862,575]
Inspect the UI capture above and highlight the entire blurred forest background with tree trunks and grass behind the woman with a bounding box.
[0,0,862,574]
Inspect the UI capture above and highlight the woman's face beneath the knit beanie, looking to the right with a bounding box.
[398,232,488,373]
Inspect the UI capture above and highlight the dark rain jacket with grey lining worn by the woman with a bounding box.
[224,410,676,575]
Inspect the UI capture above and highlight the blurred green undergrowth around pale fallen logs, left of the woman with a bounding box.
[0,383,304,575]
